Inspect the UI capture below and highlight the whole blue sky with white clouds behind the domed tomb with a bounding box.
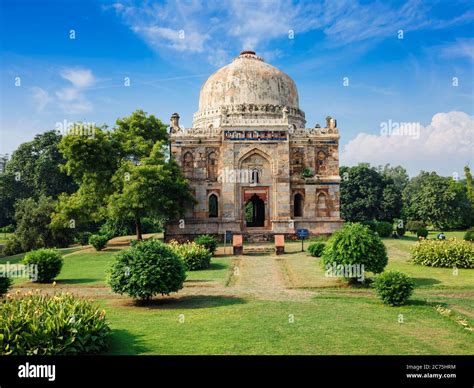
[0,0,474,175]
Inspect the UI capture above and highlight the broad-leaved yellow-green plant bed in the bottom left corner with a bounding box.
[0,291,110,356]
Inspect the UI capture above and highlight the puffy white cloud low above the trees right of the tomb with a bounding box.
[341,112,474,175]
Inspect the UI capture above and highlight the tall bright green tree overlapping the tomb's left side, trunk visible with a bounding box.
[54,110,193,239]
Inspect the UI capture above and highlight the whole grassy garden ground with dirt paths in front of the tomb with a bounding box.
[0,232,474,354]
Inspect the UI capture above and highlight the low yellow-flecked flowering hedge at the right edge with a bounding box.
[411,238,474,268]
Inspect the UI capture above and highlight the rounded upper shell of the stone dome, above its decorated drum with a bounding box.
[199,51,298,112]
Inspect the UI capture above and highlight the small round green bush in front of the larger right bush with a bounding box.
[372,271,415,306]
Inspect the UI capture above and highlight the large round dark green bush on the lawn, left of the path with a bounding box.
[107,239,187,300]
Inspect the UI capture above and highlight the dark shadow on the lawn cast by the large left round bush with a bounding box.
[133,295,247,310]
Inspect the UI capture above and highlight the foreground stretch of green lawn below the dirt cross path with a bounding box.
[103,295,474,354]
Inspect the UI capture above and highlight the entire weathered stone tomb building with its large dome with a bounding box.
[165,51,342,240]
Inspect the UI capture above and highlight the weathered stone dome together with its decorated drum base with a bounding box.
[193,51,306,128]
